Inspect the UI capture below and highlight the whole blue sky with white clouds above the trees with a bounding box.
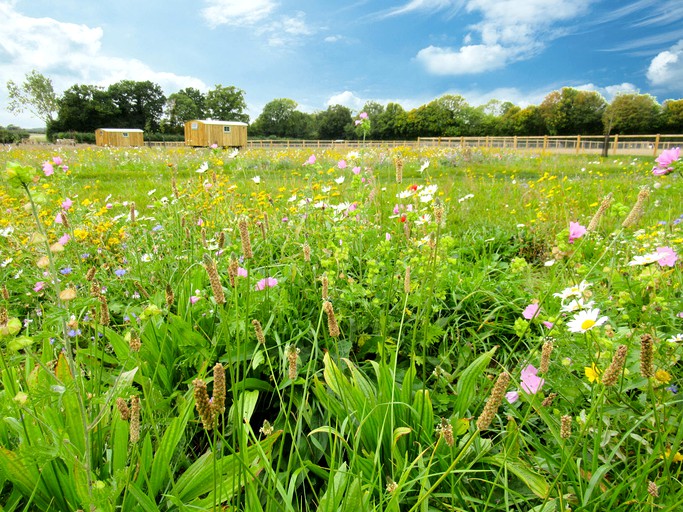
[0,0,683,127]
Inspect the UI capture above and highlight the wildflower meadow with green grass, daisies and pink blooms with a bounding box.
[0,147,683,512]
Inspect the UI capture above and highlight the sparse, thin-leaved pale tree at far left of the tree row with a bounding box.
[7,69,59,126]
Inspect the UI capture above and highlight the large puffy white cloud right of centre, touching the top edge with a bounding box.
[412,0,591,75]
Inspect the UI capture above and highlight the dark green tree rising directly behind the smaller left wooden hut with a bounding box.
[107,80,166,132]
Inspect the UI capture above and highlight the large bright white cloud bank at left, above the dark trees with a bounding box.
[0,2,208,126]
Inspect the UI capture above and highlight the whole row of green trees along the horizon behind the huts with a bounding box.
[7,71,683,140]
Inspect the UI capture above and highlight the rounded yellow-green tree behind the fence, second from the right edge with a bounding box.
[603,93,661,135]
